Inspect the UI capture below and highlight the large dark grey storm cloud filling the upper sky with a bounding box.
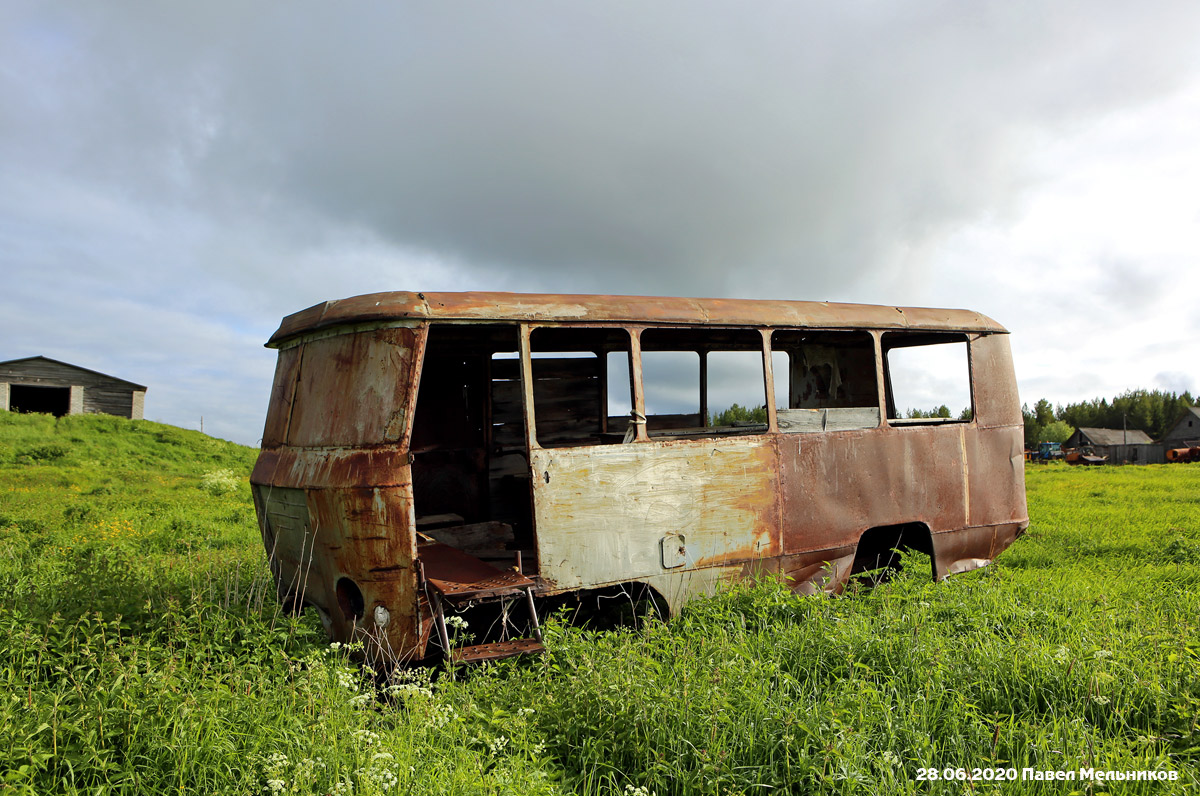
[9,2,1196,302]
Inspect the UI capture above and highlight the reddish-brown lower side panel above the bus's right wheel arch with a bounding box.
[779,424,967,555]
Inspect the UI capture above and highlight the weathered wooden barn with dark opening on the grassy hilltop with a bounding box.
[0,357,146,420]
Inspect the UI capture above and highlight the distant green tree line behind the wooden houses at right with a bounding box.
[1021,390,1195,447]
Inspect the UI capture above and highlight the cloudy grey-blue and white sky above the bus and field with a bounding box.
[0,0,1200,444]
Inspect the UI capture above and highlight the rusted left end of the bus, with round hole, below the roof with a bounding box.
[251,328,424,665]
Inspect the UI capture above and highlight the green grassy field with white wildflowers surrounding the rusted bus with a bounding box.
[0,413,1200,796]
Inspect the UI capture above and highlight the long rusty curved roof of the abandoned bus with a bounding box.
[266,292,1007,347]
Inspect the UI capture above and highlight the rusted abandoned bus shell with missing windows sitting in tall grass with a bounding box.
[252,293,1028,665]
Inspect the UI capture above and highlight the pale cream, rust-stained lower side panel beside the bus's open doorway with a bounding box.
[530,437,780,589]
